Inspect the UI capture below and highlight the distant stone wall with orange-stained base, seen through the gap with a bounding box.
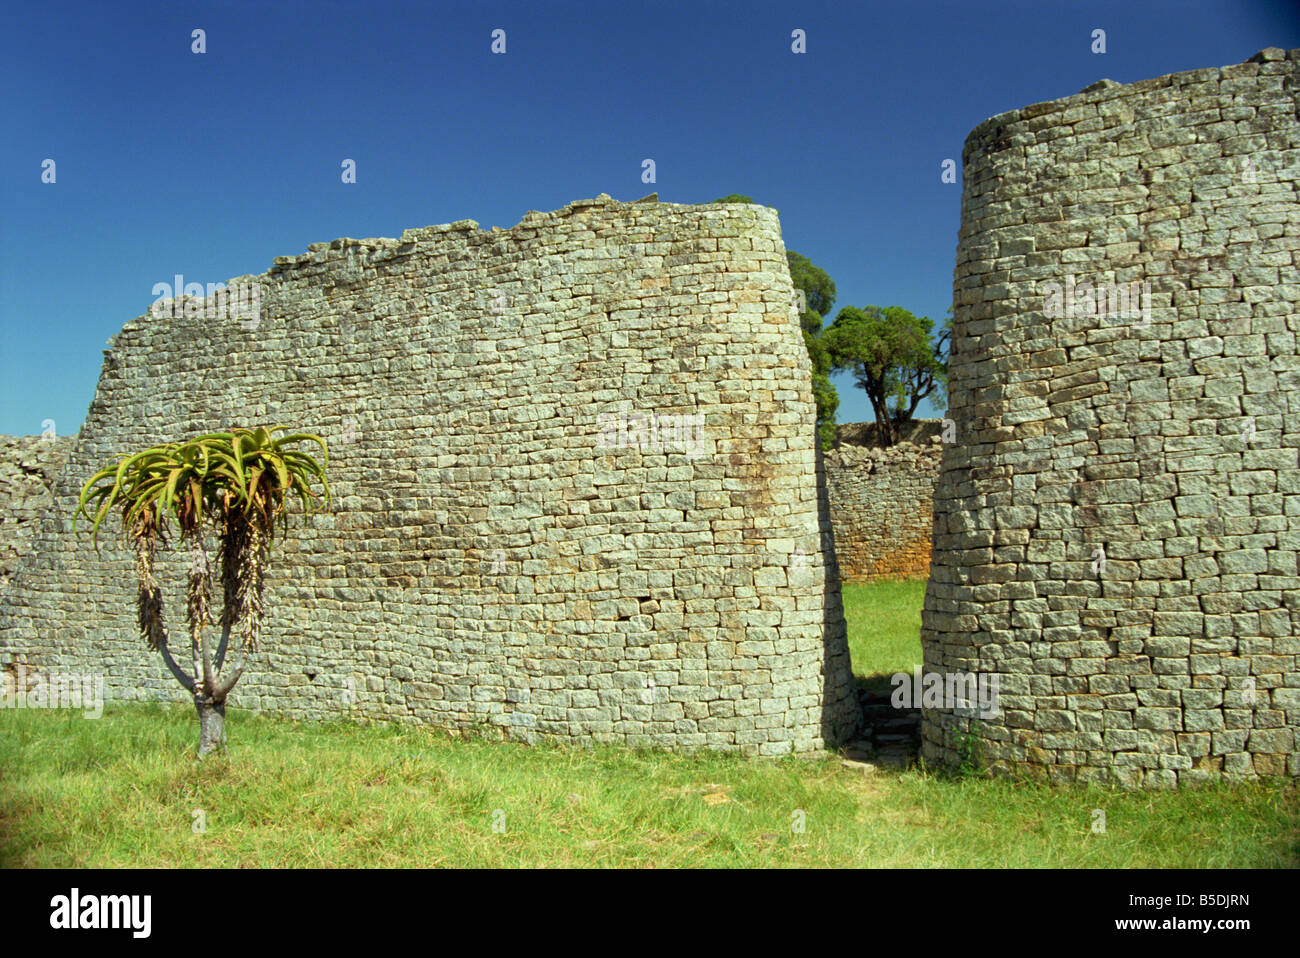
[826,422,943,581]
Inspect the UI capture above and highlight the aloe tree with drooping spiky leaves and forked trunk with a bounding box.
[73,426,330,758]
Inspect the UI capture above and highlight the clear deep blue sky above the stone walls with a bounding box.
[0,0,1300,434]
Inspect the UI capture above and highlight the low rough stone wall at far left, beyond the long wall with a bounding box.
[0,435,73,591]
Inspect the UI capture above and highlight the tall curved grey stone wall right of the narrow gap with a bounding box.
[923,49,1300,785]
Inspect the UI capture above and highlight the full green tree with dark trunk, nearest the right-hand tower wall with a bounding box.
[822,305,952,445]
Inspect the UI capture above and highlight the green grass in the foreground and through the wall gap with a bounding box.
[0,574,1300,867]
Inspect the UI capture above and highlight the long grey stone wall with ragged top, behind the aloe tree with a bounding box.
[0,196,858,754]
